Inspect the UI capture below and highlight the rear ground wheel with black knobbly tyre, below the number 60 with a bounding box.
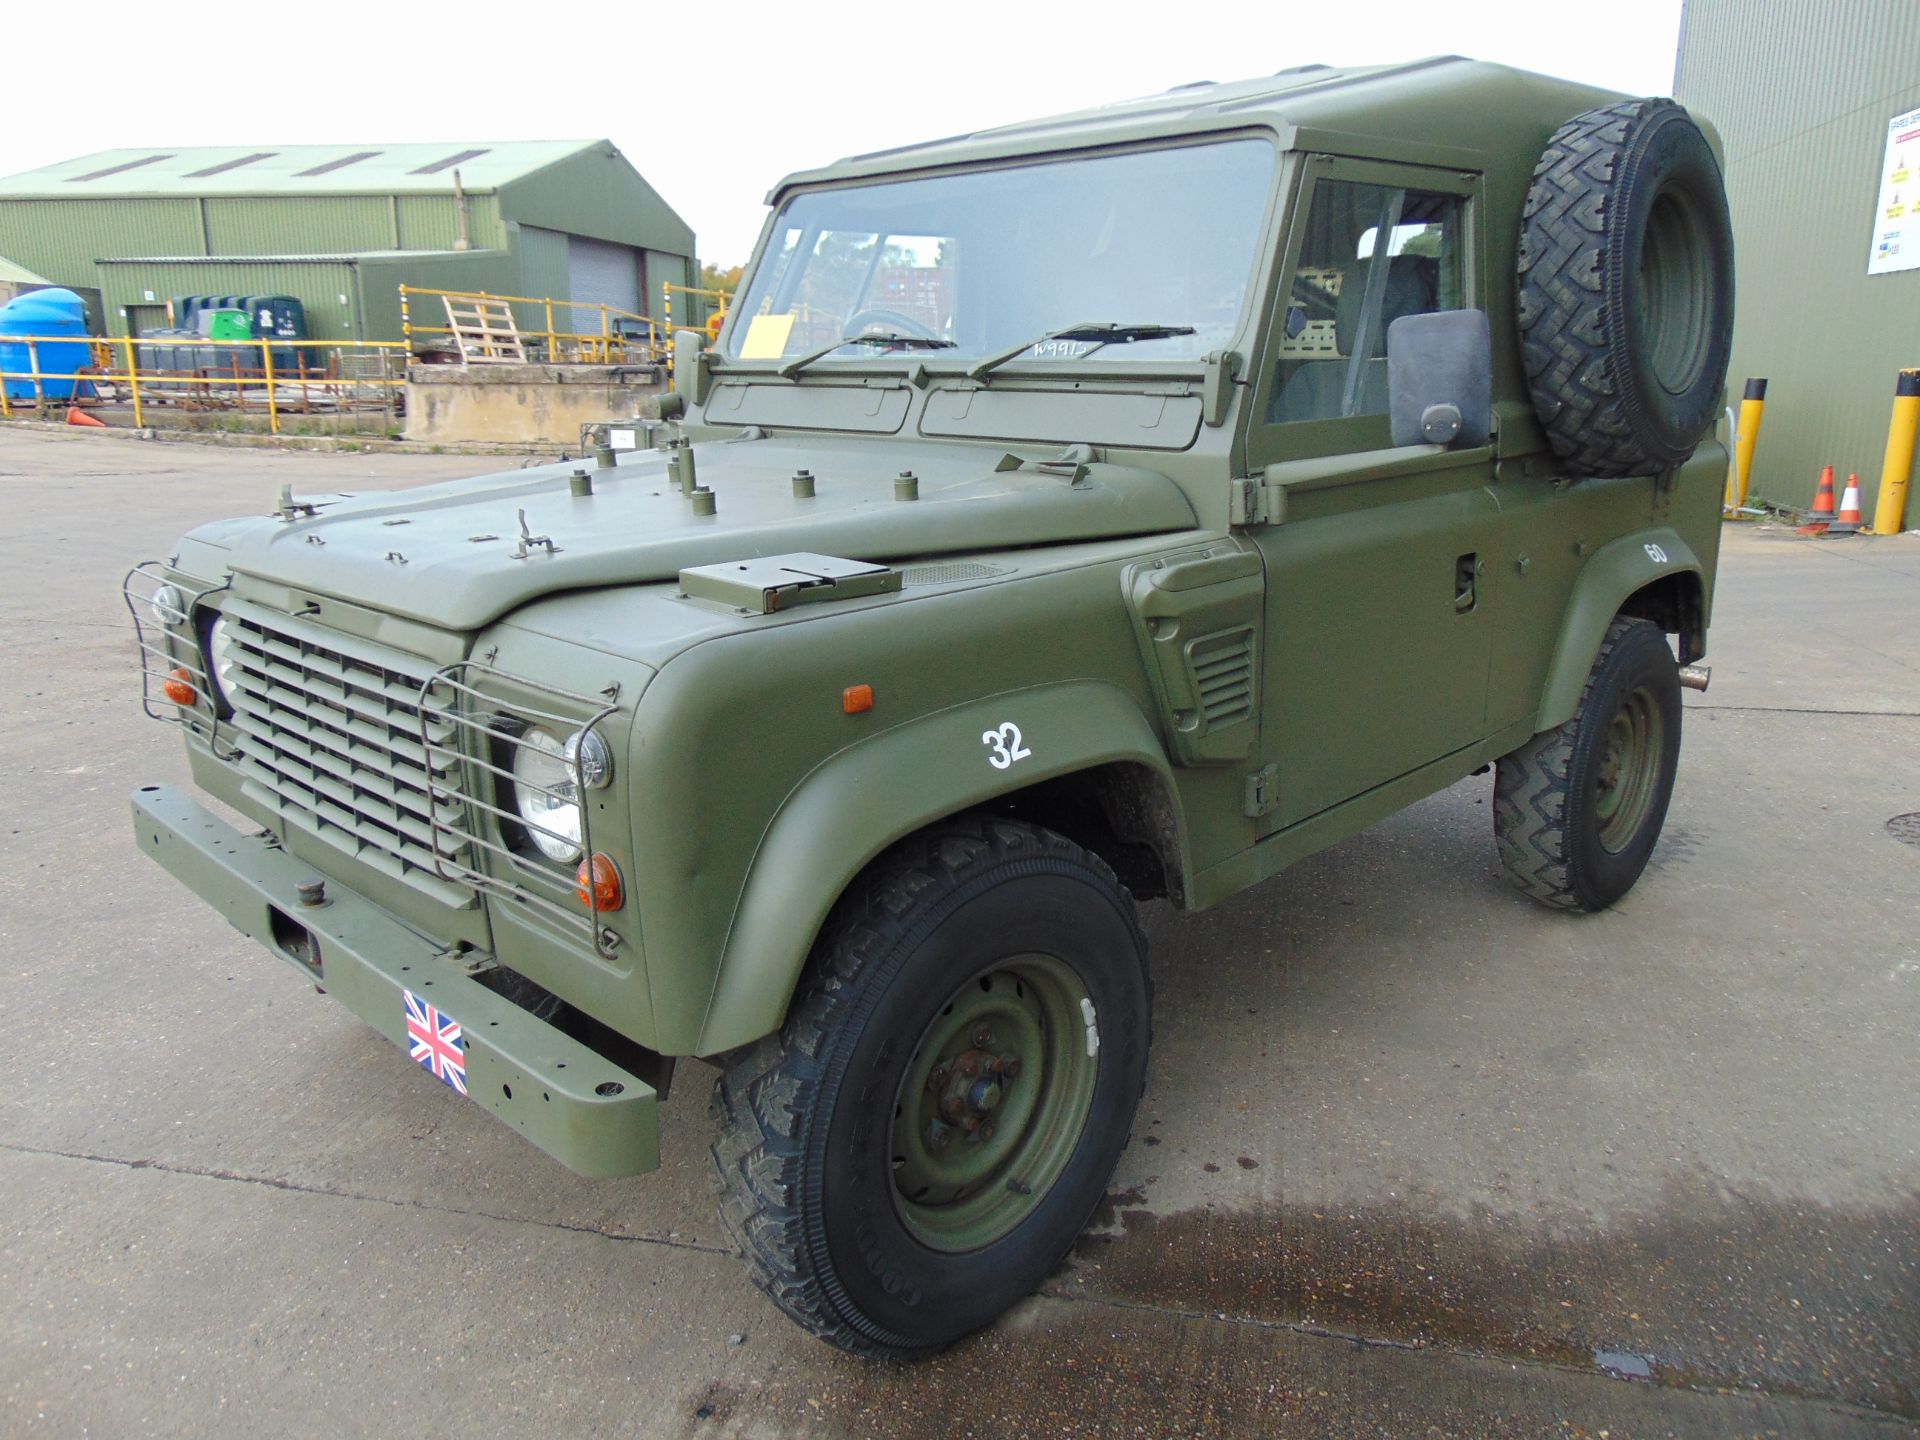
[1494,618,1680,910]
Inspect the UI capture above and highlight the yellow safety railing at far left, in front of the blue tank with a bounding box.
[0,334,407,434]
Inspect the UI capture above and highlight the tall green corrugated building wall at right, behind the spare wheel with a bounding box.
[1674,0,1920,524]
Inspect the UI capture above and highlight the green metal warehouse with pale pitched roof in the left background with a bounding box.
[0,140,697,340]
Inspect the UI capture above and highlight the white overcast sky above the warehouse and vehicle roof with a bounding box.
[0,0,1680,265]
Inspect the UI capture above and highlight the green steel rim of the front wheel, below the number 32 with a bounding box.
[893,954,1100,1254]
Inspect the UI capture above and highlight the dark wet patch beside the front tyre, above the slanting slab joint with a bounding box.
[1048,1179,1920,1417]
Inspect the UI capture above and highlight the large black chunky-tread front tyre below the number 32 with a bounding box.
[712,816,1152,1356]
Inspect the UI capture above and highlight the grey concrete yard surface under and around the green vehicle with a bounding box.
[0,434,1920,1440]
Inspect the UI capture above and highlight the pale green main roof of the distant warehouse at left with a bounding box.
[0,140,612,200]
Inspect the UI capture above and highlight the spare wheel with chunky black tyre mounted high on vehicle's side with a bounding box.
[1519,100,1734,485]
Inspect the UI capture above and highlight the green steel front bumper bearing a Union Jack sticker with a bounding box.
[132,785,660,1177]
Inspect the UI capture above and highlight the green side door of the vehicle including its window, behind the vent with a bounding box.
[1248,156,1498,833]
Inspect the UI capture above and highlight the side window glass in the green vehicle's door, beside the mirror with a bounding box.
[1267,180,1463,424]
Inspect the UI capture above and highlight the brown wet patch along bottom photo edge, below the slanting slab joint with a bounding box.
[680,1296,1908,1440]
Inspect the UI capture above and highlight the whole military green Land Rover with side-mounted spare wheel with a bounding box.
[127,60,1732,1354]
